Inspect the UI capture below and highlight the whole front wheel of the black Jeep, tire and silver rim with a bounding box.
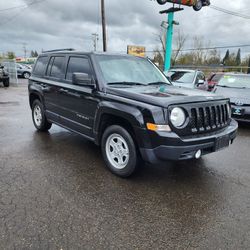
[101,125,140,178]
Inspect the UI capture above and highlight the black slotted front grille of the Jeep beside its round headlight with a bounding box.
[171,101,231,136]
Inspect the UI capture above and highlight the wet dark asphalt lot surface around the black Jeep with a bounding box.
[0,81,250,250]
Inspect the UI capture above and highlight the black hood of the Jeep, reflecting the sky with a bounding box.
[106,85,225,107]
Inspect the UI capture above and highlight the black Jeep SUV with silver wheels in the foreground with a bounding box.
[29,51,238,177]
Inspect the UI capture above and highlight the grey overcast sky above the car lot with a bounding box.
[0,0,250,56]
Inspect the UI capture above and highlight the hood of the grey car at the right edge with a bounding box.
[214,86,250,105]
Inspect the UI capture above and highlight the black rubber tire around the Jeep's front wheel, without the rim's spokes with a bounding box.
[101,125,140,178]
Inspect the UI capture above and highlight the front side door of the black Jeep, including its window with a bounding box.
[58,55,99,138]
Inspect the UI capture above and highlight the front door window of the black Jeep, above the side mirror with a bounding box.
[66,57,92,81]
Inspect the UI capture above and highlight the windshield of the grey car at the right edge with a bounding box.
[218,75,250,88]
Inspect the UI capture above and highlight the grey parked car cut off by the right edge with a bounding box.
[214,74,250,122]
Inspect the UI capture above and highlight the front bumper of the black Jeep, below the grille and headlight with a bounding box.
[140,120,238,164]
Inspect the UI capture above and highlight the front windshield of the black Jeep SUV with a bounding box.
[96,55,170,85]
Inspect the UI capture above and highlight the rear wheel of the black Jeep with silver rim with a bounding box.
[32,100,52,132]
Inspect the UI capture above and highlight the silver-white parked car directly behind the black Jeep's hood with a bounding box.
[165,69,208,91]
